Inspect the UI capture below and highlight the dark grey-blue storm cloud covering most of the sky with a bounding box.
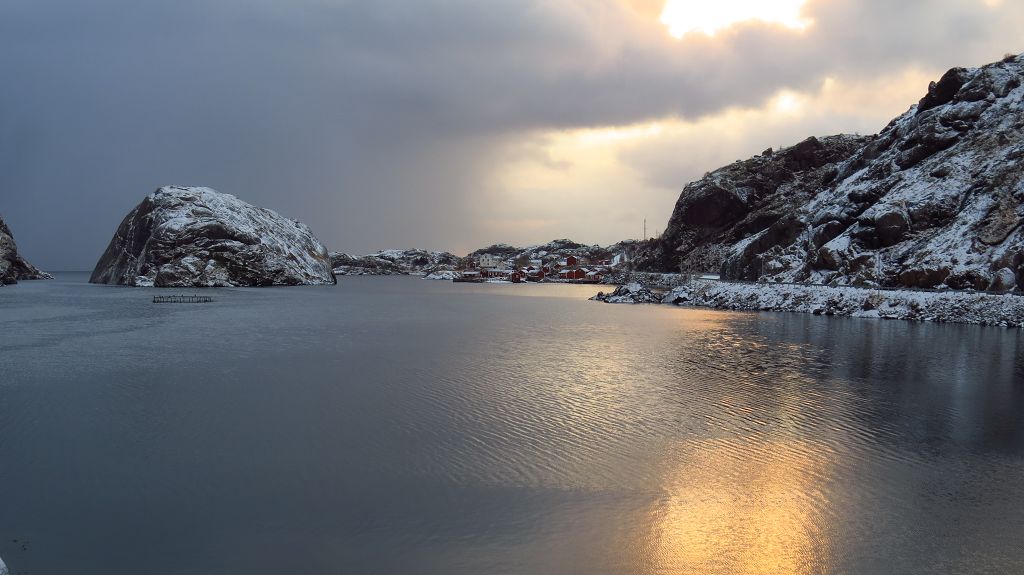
[0,0,1021,269]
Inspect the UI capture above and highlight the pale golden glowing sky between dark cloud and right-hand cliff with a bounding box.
[483,69,941,244]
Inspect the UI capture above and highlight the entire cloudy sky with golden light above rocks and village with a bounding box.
[0,0,1024,270]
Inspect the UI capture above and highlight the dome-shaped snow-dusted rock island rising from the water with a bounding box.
[90,186,335,288]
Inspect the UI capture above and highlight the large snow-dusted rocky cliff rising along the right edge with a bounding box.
[647,56,1024,291]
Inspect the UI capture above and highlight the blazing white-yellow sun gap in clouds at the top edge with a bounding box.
[662,0,810,38]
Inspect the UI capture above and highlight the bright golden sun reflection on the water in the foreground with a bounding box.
[639,439,835,574]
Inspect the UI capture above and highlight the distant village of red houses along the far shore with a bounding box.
[452,253,629,283]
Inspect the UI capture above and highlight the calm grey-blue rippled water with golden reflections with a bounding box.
[0,274,1024,575]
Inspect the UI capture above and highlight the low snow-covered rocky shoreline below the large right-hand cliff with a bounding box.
[592,279,1024,328]
